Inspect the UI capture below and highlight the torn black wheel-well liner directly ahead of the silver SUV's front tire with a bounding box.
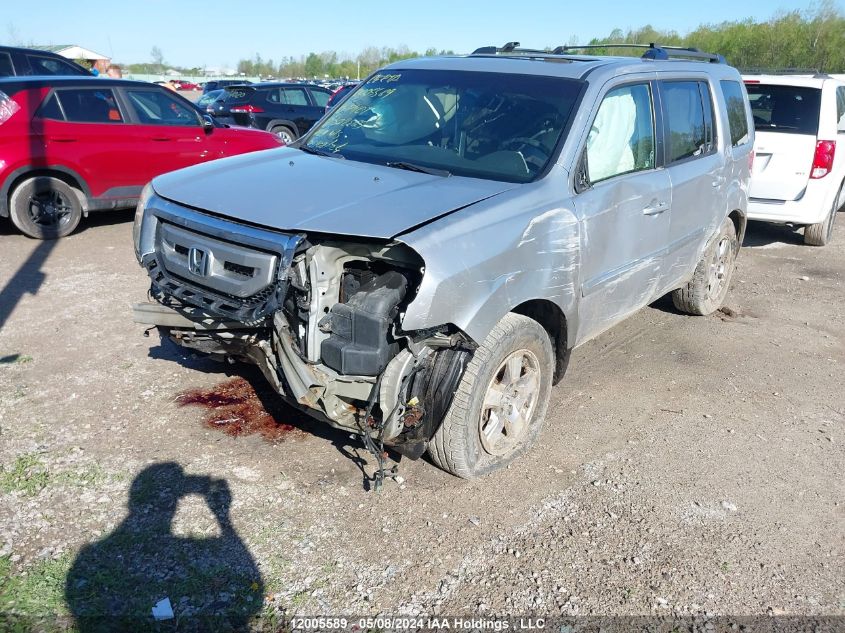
[391,348,471,459]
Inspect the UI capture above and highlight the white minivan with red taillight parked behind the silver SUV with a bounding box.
[743,74,845,246]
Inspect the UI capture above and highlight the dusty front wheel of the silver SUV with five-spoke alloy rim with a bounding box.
[428,313,555,479]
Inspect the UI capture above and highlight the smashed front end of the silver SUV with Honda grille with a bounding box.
[134,188,475,458]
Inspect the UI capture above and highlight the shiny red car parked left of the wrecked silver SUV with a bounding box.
[0,77,280,239]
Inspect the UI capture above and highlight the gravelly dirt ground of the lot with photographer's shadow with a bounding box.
[0,212,845,627]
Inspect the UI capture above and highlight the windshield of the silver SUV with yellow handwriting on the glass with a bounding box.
[305,70,582,182]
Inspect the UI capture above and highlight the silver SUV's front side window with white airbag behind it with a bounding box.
[587,84,654,183]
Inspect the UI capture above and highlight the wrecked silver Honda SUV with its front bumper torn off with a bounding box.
[134,43,754,477]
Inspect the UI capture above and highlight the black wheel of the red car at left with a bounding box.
[9,176,82,240]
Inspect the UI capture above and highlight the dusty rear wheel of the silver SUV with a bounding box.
[672,218,739,316]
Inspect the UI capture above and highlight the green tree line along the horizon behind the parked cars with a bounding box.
[123,0,845,79]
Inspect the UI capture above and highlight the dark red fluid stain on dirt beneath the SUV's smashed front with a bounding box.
[176,378,302,442]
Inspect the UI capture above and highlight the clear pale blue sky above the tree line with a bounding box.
[0,0,841,67]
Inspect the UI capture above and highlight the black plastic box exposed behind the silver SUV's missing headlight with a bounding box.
[320,270,408,376]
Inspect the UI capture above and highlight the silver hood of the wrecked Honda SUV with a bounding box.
[153,148,520,239]
